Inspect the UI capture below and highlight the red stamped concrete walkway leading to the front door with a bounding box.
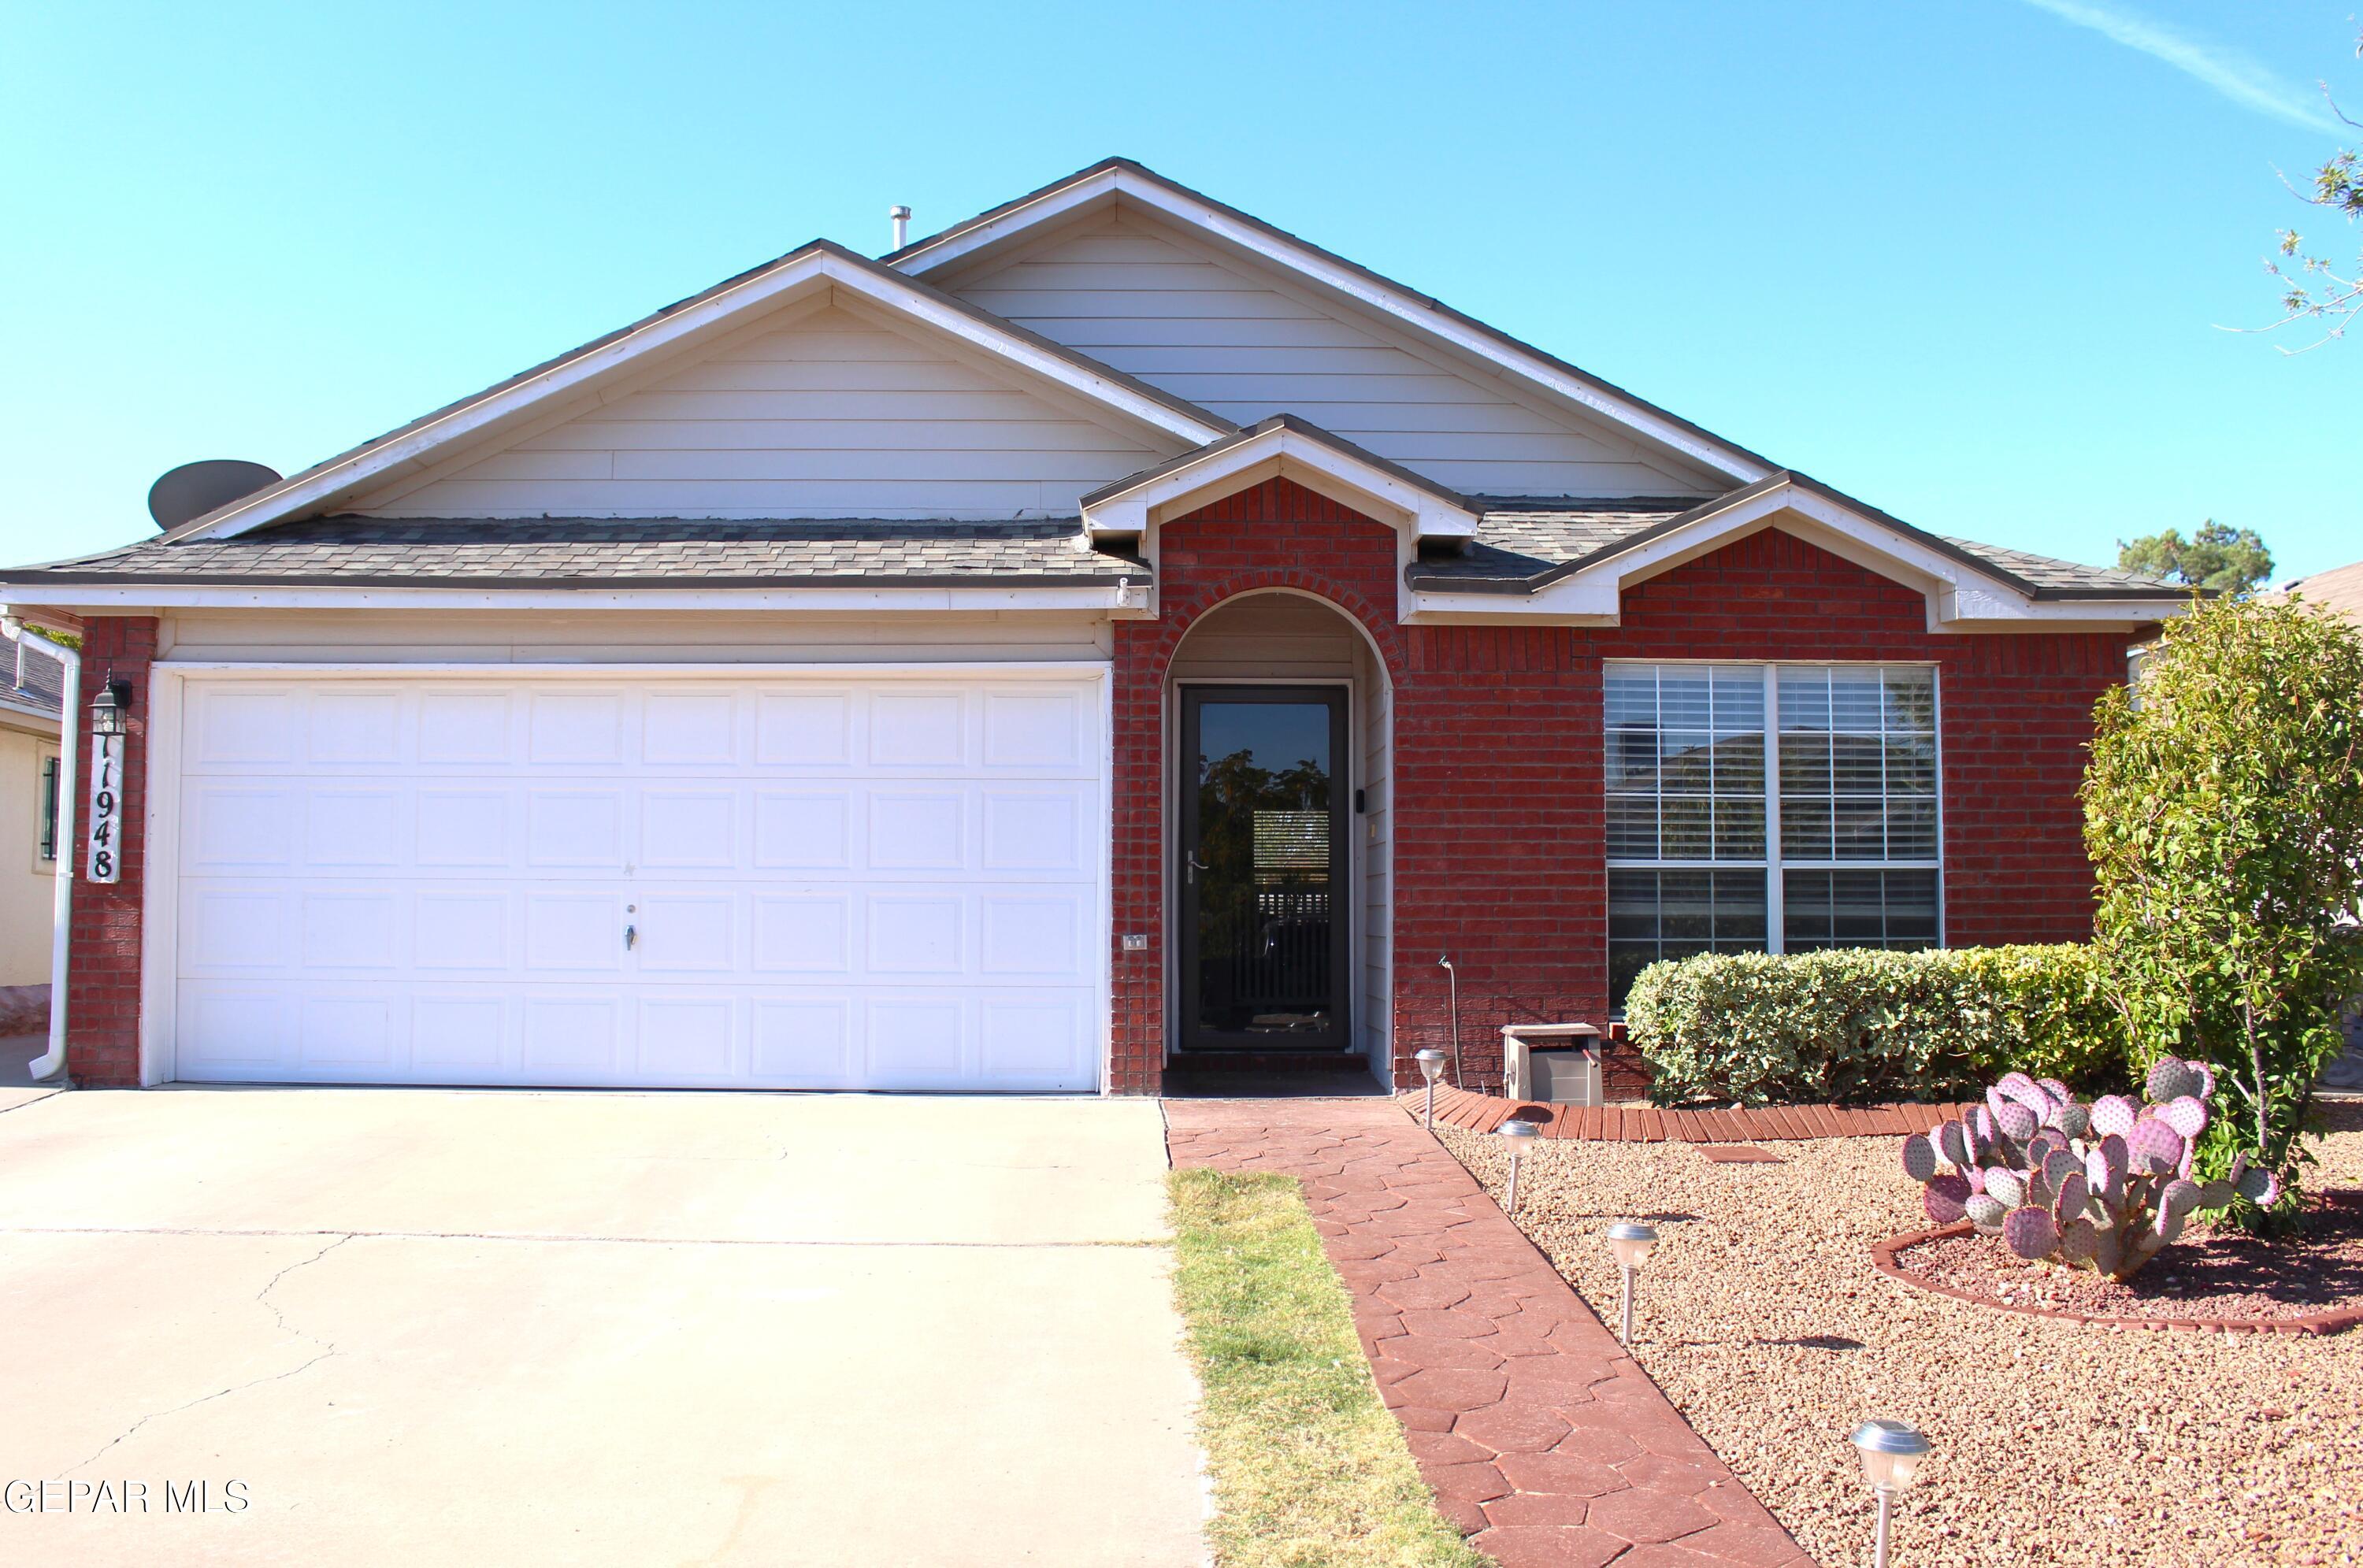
[1165,1100,1812,1568]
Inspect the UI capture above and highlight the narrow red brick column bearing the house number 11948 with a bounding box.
[66,617,156,1088]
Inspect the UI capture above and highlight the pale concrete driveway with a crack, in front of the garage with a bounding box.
[0,1088,1205,1568]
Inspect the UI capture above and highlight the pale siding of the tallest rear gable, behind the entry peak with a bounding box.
[931,208,1730,496]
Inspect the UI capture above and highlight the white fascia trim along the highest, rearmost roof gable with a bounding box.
[900,168,1772,484]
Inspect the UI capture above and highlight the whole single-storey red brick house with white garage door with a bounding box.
[0,161,2181,1093]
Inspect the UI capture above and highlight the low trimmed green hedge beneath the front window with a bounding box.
[1626,944,2131,1105]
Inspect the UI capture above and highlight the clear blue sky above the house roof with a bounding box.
[0,0,2363,579]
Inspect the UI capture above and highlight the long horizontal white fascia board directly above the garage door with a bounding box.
[0,584,1144,617]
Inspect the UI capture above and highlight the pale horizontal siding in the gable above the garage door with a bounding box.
[354,302,1184,520]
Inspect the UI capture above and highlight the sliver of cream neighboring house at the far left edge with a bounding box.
[0,643,64,992]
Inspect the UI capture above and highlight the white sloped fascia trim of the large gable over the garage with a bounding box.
[189,250,1231,539]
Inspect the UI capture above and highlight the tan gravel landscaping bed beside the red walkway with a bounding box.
[1437,1107,2363,1568]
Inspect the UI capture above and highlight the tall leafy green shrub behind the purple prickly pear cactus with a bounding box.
[2084,600,2363,1228]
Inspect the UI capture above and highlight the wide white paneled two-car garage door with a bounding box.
[175,673,1106,1091]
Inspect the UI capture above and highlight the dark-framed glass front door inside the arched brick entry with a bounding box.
[1174,688,1352,1051]
